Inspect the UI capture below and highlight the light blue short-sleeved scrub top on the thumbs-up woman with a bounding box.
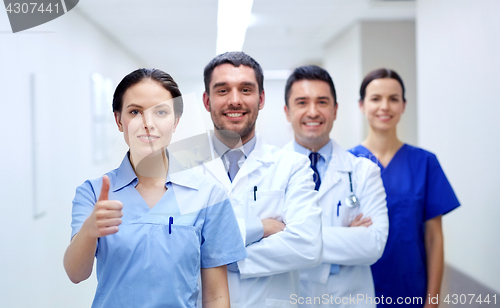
[71,155,247,307]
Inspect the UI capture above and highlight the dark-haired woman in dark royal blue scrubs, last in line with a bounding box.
[350,69,460,307]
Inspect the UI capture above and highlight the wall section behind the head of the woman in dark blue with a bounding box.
[323,21,418,149]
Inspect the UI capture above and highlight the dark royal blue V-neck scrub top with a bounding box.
[349,144,460,307]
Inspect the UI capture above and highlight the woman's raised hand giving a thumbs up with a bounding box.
[82,175,123,239]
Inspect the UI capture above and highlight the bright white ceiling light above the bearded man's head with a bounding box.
[217,0,253,54]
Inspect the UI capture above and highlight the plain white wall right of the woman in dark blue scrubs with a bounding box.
[417,0,500,292]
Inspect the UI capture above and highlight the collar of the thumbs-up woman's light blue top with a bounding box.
[113,152,199,191]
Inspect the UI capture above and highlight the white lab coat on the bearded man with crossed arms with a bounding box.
[181,135,323,308]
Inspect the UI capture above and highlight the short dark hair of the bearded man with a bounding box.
[203,51,264,94]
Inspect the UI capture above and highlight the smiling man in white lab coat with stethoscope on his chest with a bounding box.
[285,65,389,307]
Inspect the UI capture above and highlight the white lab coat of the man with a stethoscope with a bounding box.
[284,139,389,307]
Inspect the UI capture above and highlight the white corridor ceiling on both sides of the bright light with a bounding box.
[76,0,415,79]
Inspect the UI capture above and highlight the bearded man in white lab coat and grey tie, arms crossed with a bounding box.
[193,52,323,308]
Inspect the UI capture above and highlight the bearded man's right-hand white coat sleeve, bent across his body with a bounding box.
[238,157,323,278]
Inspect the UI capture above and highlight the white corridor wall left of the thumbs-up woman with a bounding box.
[0,9,142,308]
